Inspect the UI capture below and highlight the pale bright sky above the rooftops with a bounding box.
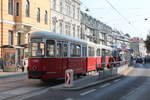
[80,0,150,39]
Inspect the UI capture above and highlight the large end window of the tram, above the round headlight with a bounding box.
[31,43,45,57]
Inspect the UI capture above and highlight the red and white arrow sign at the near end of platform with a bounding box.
[65,69,73,87]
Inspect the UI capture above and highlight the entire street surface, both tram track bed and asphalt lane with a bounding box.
[0,64,150,100]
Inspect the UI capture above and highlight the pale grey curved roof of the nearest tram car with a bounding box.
[30,31,87,44]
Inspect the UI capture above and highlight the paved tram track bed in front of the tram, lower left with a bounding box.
[0,74,62,100]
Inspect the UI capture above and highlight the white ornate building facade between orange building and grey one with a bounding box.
[51,0,81,38]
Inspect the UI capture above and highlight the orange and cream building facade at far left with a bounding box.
[0,0,51,70]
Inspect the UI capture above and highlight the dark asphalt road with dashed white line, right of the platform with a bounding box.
[24,64,150,100]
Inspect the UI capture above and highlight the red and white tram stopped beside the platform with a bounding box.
[28,31,113,80]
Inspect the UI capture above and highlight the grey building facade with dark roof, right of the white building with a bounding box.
[81,12,111,45]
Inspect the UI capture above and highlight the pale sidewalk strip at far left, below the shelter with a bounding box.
[0,70,27,78]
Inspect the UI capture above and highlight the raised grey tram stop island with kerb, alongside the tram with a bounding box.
[50,67,133,90]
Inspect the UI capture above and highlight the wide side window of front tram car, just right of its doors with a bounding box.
[70,44,81,57]
